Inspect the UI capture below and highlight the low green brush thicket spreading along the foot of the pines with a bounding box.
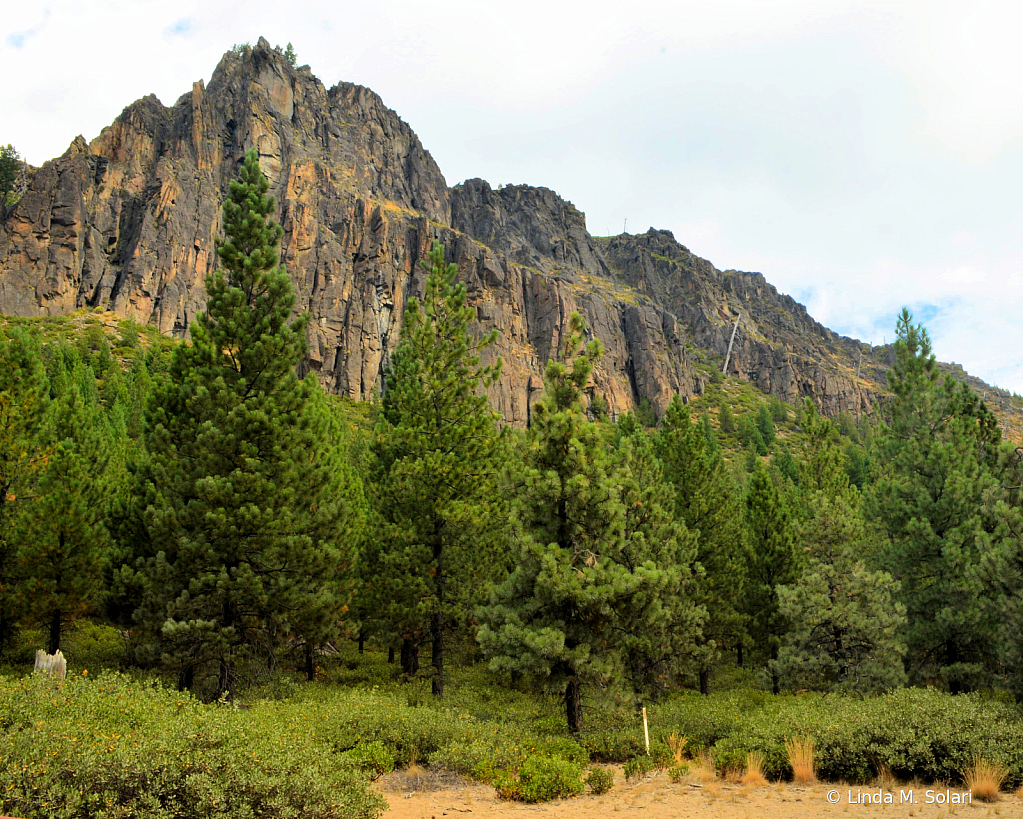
[0,641,1023,819]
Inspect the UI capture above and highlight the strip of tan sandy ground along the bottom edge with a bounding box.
[376,769,1023,819]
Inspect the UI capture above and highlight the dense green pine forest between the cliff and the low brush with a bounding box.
[0,153,1023,732]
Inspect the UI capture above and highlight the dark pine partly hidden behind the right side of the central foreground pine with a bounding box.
[655,396,746,694]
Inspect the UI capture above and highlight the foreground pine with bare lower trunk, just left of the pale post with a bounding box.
[479,313,665,733]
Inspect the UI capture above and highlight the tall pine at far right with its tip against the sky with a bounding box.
[866,310,1008,693]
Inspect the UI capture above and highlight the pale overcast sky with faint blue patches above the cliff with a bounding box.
[0,0,1023,394]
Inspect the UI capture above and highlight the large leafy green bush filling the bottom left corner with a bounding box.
[0,674,385,819]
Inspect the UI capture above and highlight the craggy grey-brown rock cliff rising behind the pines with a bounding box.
[0,39,1023,424]
